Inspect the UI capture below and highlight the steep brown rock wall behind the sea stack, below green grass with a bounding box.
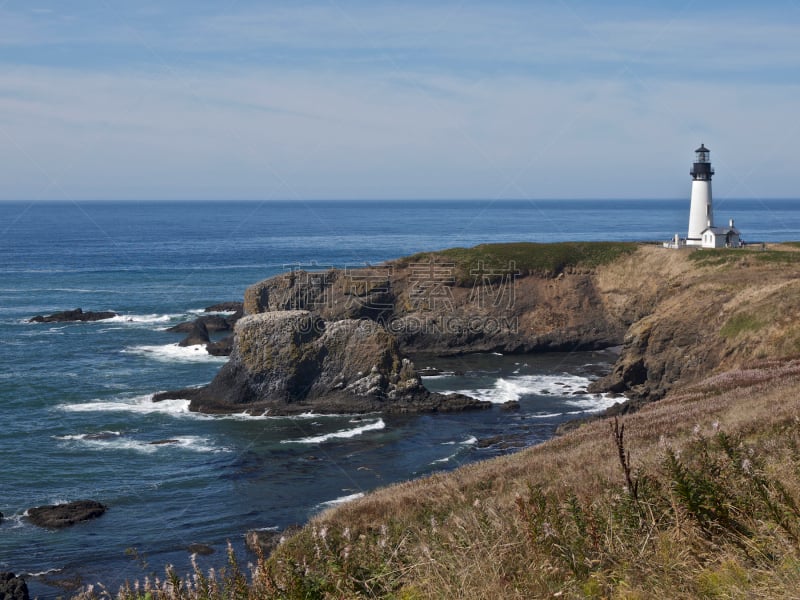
[244,264,629,355]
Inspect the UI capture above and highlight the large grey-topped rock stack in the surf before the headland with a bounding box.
[155,310,488,414]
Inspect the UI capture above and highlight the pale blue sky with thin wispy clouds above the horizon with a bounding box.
[0,0,800,200]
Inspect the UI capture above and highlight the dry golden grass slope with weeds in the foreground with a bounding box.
[267,361,800,598]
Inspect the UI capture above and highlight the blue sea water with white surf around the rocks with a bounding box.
[0,200,800,597]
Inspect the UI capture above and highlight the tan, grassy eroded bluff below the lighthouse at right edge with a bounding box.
[590,245,800,401]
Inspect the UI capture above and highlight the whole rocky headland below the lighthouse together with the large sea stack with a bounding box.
[177,242,800,412]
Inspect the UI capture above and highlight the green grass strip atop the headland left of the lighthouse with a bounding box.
[398,242,638,284]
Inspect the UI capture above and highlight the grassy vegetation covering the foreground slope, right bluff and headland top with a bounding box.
[70,244,800,600]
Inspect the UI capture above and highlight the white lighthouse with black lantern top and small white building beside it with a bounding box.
[664,144,742,248]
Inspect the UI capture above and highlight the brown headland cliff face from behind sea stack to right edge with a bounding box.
[239,245,800,408]
